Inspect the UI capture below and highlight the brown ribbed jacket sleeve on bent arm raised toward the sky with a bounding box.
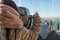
[16,14,41,40]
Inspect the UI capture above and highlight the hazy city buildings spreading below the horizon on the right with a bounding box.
[40,18,60,39]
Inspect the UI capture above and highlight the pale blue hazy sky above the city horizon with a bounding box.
[14,0,60,17]
